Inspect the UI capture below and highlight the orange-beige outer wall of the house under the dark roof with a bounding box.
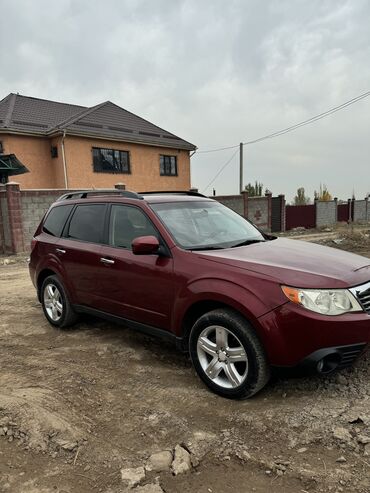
[0,134,191,192]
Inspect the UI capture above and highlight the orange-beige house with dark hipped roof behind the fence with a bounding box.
[0,94,196,191]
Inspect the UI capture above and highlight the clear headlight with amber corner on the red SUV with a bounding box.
[281,286,363,315]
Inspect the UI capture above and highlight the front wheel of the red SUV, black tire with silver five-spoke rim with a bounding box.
[189,309,270,399]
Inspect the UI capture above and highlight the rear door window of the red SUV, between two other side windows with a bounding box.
[68,204,105,243]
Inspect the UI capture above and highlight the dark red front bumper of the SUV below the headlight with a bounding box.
[257,302,370,367]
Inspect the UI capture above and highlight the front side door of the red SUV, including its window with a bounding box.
[98,204,174,330]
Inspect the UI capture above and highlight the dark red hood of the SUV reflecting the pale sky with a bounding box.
[200,238,370,288]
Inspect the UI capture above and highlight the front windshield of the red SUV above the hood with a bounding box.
[151,200,265,250]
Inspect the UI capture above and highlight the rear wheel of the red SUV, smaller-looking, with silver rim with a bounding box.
[40,275,78,329]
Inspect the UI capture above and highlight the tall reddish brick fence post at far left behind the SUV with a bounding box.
[5,182,25,253]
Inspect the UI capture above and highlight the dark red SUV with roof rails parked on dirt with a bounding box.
[30,191,370,398]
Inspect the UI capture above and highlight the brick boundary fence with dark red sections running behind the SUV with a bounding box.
[0,182,370,254]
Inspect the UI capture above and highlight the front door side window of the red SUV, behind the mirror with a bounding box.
[109,204,159,250]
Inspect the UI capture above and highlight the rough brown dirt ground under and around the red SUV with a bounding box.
[0,229,370,493]
